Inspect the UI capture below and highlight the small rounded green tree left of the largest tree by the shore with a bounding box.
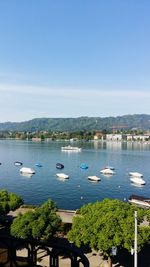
[11,199,61,241]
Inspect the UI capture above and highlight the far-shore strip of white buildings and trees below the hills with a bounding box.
[0,129,150,144]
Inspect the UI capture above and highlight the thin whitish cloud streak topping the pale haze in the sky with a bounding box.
[0,84,150,98]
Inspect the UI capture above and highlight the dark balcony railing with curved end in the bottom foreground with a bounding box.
[0,236,89,267]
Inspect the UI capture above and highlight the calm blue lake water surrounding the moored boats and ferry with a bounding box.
[0,140,150,209]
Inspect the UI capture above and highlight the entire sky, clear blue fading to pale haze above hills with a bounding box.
[0,0,150,122]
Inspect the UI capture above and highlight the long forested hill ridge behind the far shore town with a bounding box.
[0,114,150,132]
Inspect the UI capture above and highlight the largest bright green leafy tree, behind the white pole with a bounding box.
[68,199,150,266]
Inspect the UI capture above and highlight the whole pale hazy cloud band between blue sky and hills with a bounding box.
[0,84,150,121]
